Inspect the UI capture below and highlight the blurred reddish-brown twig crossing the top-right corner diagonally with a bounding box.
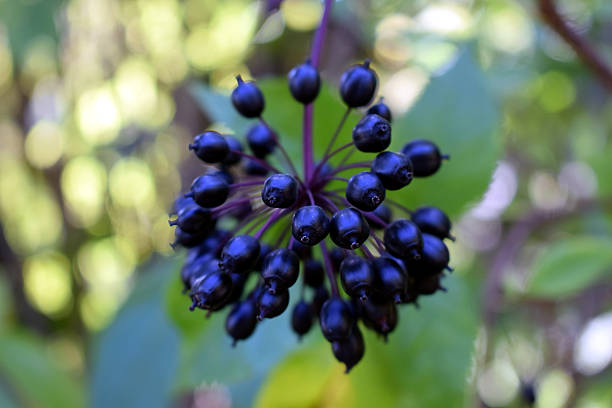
[538,0,612,92]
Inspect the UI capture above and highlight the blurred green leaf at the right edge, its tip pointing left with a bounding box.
[527,237,612,300]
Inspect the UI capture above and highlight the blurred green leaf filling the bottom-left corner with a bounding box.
[0,331,85,408]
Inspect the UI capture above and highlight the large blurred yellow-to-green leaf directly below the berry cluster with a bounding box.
[251,275,479,408]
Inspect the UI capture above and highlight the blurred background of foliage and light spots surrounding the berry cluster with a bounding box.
[0,0,612,408]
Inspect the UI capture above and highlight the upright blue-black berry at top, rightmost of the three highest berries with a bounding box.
[340,60,378,108]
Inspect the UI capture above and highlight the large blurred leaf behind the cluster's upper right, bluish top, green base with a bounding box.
[389,50,500,216]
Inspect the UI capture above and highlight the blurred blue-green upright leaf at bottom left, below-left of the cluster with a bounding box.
[92,260,178,407]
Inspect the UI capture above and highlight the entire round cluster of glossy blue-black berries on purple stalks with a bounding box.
[170,61,453,372]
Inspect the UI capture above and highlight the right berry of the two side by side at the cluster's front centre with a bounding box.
[329,208,370,250]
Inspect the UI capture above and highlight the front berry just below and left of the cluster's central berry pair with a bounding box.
[261,248,300,294]
